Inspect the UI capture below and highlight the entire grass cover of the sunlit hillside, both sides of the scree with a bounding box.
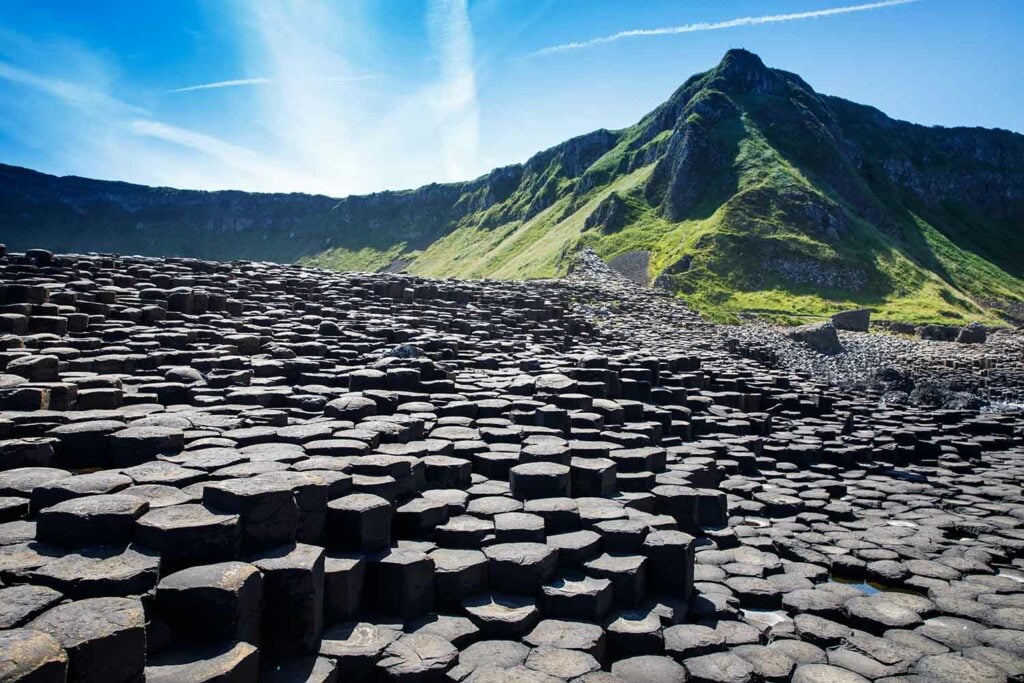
[294,58,1024,323]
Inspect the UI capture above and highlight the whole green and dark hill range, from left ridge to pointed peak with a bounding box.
[0,50,1024,322]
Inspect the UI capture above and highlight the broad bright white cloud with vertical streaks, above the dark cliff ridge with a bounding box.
[237,0,482,196]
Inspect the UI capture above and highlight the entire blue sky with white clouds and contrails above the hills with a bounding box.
[0,0,1024,197]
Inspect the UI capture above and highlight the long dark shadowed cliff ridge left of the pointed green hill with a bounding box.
[0,125,617,262]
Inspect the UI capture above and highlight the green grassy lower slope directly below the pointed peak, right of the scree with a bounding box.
[659,112,1011,323]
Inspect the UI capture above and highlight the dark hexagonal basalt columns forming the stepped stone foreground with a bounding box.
[0,249,1024,683]
